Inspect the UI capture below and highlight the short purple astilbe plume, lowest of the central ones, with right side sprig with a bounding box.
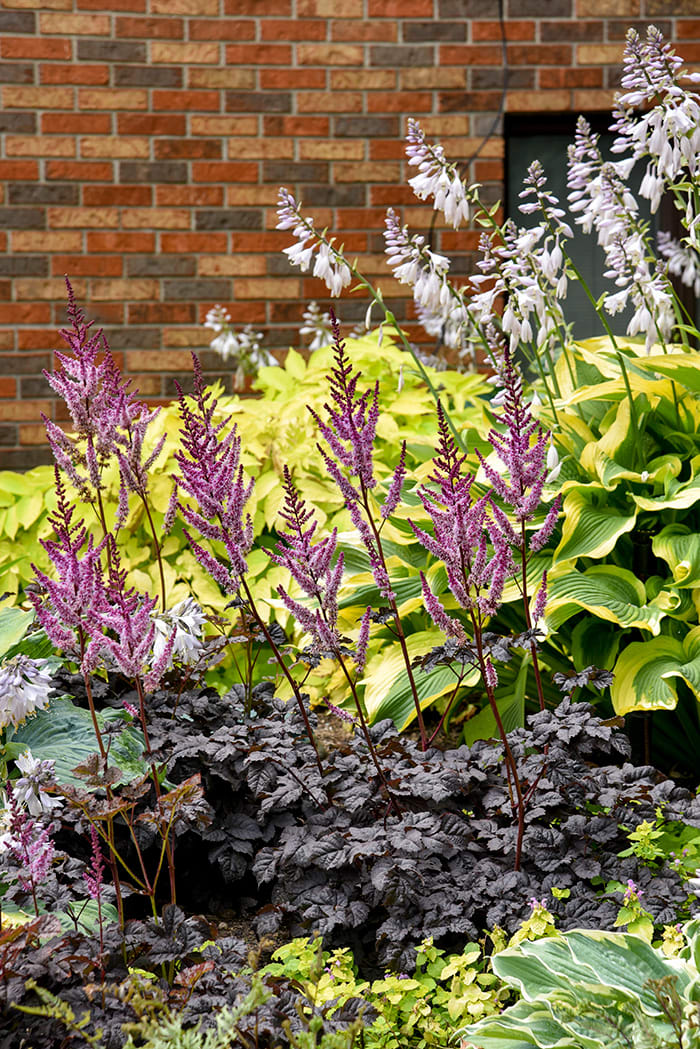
[269,467,372,667]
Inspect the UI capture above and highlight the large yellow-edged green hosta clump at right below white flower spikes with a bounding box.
[547,338,700,730]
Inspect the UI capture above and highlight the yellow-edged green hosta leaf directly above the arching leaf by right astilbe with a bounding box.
[554,486,637,564]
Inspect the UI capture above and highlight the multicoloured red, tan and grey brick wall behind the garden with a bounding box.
[0,0,700,469]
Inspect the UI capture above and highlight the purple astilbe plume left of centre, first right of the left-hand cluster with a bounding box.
[175,354,254,593]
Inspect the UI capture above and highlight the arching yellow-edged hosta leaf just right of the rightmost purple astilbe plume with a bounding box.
[546,564,665,635]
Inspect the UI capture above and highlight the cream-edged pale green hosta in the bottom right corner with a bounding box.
[457,921,700,1049]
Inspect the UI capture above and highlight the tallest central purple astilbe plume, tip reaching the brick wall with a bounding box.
[309,316,406,600]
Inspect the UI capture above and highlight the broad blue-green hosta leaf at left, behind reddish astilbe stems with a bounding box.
[12,697,148,785]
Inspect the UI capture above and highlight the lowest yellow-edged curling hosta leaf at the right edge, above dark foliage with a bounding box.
[611,626,700,714]
